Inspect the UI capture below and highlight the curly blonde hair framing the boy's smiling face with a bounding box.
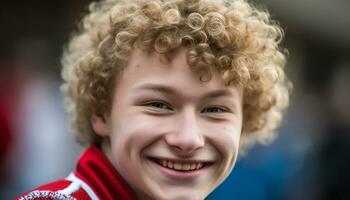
[62,0,290,150]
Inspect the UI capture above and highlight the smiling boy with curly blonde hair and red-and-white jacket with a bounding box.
[19,0,288,200]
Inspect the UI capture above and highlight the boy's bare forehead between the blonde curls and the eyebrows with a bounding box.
[117,49,241,99]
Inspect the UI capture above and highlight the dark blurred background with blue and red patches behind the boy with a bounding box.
[0,0,350,200]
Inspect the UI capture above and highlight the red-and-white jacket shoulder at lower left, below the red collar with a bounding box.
[16,173,97,200]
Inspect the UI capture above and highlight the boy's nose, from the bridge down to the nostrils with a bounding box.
[165,110,204,154]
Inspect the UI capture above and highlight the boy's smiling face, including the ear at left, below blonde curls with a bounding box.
[92,49,242,200]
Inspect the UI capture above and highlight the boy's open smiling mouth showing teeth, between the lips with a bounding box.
[150,158,212,172]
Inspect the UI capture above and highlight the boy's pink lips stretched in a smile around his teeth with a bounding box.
[147,158,213,181]
